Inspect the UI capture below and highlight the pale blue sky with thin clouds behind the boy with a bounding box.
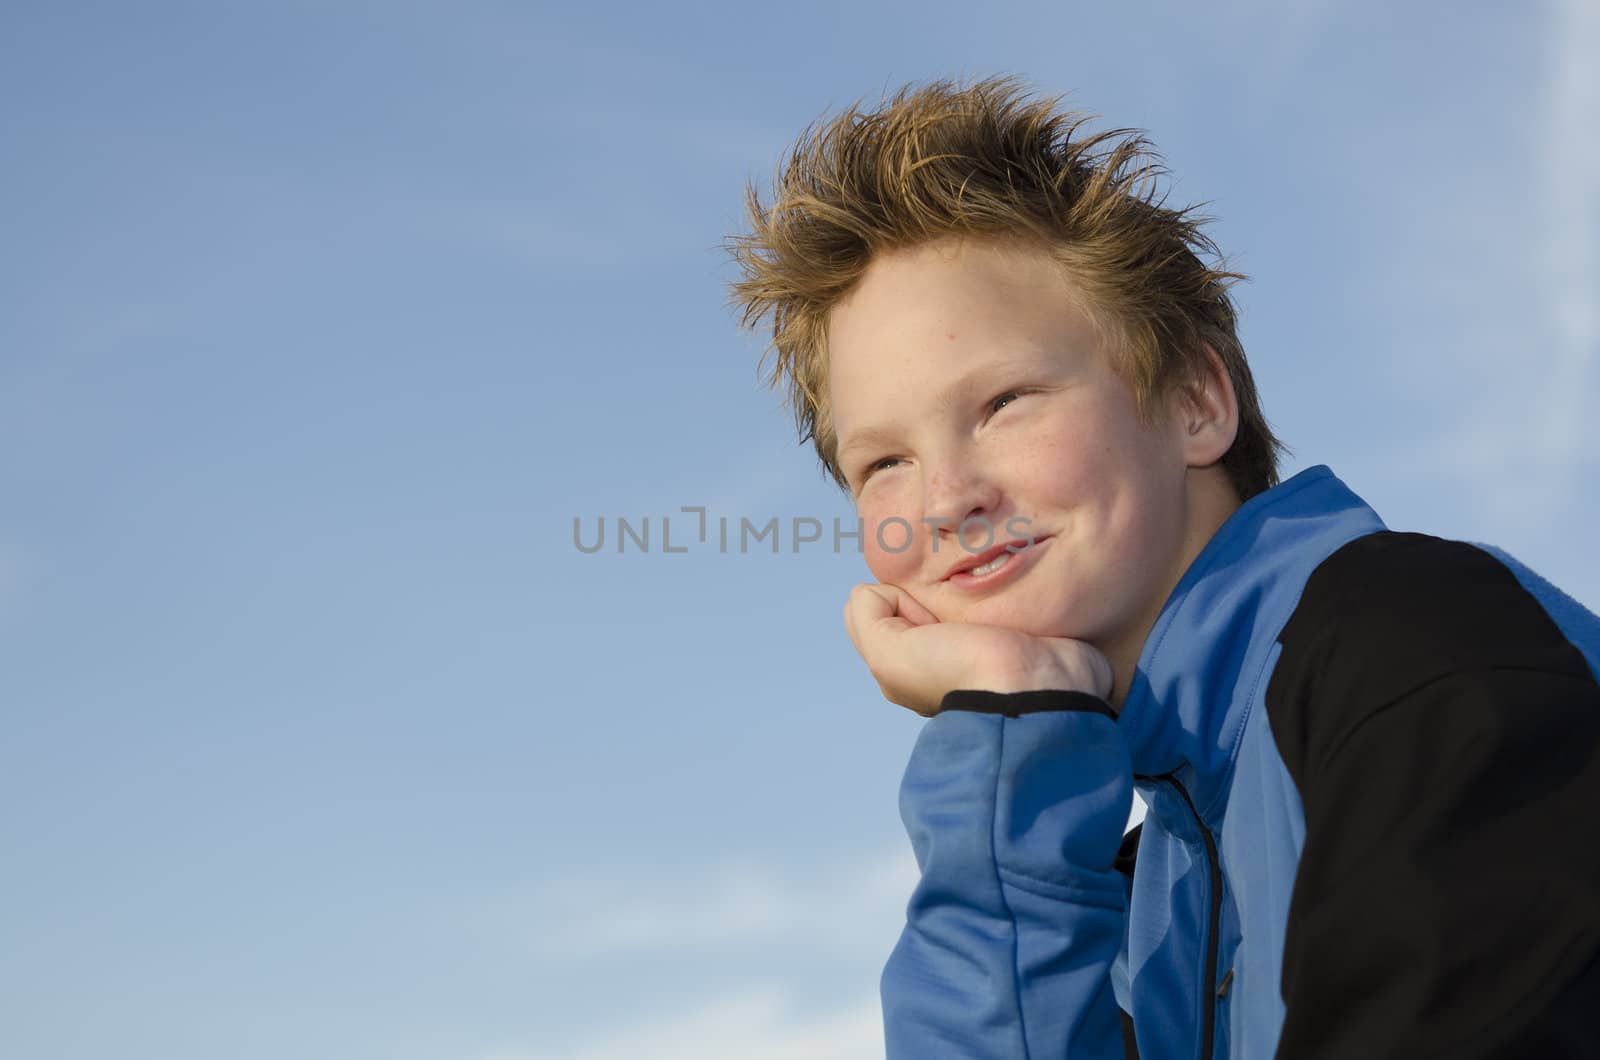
[0,0,1600,1060]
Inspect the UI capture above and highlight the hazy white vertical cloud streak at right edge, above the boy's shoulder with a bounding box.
[1382,0,1600,543]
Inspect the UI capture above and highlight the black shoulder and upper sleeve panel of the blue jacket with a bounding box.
[1266,532,1600,1060]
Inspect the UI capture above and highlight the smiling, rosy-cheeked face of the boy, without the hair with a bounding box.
[829,240,1194,658]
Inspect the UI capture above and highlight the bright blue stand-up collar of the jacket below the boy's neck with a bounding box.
[1117,464,1384,831]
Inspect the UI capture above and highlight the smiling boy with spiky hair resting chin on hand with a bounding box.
[733,78,1600,1060]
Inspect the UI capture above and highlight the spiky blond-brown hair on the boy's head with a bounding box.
[728,77,1285,501]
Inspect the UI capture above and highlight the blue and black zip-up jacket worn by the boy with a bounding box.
[882,466,1600,1060]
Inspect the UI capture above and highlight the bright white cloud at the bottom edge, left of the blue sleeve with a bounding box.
[477,986,883,1060]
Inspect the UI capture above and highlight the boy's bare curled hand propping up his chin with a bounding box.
[845,584,1112,717]
